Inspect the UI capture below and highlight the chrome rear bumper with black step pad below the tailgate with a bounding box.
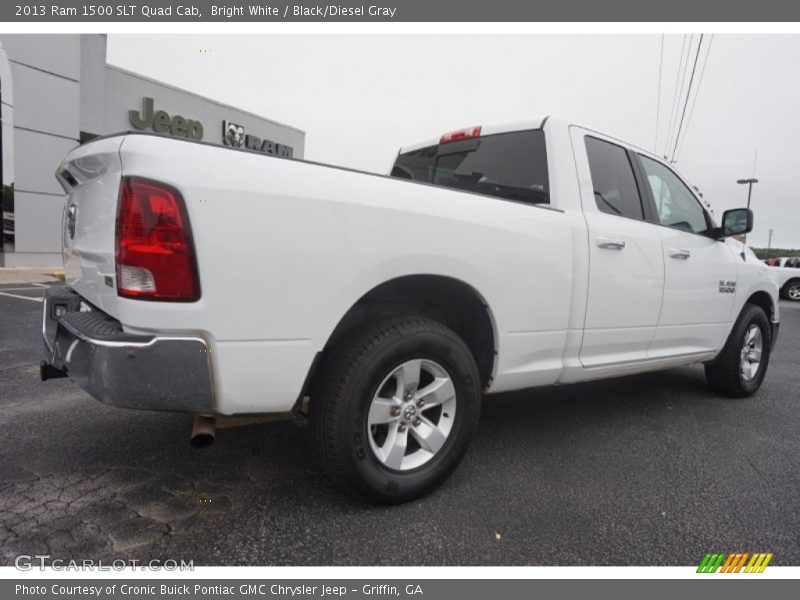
[42,286,214,413]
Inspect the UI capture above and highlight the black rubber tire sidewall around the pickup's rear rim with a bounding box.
[337,330,480,502]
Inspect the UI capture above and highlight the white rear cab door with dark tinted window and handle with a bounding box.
[572,128,664,368]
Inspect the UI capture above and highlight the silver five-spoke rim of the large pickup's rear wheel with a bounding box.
[367,359,456,471]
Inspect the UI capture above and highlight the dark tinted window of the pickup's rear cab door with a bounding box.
[586,137,644,220]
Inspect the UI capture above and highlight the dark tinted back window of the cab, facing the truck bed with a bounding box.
[392,129,550,204]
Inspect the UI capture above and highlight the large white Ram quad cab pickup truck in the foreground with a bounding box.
[41,118,779,502]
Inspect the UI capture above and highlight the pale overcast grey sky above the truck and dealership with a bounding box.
[108,34,800,248]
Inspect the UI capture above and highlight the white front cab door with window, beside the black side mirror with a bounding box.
[637,155,742,358]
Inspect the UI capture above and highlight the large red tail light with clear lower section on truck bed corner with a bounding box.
[116,177,200,302]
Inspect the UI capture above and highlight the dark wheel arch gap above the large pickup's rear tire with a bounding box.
[322,275,498,388]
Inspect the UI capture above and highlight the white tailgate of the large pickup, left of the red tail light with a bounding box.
[56,136,124,317]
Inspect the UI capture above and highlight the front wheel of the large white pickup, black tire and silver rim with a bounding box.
[706,304,772,398]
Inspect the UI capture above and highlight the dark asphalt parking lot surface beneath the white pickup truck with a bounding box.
[0,283,800,565]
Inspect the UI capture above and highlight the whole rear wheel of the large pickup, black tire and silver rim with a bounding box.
[309,317,481,504]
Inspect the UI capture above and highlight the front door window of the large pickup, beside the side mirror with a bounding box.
[640,155,708,234]
